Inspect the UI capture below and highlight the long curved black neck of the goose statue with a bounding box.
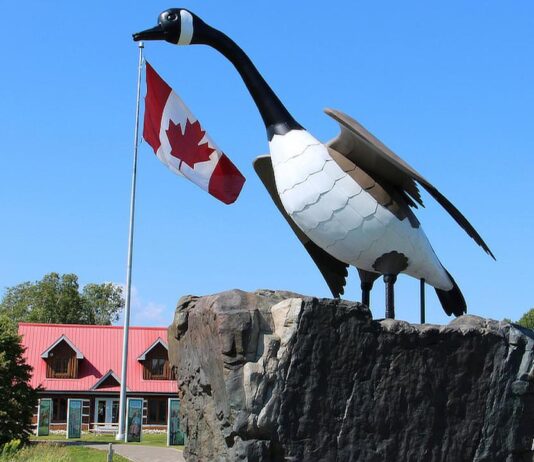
[192,23,302,140]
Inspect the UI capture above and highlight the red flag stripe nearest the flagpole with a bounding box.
[143,62,172,152]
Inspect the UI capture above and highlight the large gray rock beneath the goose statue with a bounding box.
[169,290,534,462]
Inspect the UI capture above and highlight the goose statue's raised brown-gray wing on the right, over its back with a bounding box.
[325,109,495,259]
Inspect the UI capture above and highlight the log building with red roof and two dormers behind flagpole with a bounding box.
[19,323,178,430]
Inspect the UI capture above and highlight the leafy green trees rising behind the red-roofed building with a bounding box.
[0,273,124,325]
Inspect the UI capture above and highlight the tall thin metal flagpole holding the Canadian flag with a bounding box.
[116,42,144,440]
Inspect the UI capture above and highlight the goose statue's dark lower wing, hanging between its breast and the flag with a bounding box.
[254,156,349,298]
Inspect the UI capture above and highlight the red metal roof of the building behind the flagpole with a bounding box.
[19,322,178,393]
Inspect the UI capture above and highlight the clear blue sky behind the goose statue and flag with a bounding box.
[0,0,534,325]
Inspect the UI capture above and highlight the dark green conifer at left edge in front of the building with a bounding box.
[0,316,37,446]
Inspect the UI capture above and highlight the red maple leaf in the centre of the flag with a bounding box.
[169,119,215,168]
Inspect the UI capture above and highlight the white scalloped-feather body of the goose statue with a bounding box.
[269,130,452,290]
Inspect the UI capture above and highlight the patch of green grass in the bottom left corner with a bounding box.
[0,444,129,462]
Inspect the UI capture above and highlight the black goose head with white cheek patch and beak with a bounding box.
[133,8,205,45]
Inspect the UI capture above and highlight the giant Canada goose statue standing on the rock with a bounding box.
[133,8,493,318]
